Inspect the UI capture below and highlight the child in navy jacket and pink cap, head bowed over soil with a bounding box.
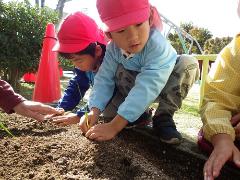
[53,12,106,126]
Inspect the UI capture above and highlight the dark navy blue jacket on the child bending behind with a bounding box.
[58,68,95,117]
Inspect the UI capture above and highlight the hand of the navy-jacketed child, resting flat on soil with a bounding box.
[52,113,80,126]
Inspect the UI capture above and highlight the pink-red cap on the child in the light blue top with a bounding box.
[97,0,150,32]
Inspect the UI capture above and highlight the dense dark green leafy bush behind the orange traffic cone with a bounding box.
[0,1,58,87]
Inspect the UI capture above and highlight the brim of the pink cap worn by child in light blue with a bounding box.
[103,7,150,32]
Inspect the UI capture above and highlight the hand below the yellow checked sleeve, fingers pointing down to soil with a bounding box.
[203,134,240,180]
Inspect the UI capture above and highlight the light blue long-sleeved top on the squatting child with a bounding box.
[89,29,177,122]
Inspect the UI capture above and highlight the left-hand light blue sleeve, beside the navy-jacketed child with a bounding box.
[88,44,118,111]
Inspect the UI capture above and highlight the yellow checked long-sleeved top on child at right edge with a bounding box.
[200,34,240,141]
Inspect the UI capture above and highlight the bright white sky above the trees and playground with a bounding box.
[3,0,240,37]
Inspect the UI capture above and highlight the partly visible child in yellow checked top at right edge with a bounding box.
[198,1,240,180]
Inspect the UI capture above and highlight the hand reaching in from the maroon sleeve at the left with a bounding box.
[13,101,64,122]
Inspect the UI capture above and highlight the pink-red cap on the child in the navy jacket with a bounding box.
[52,12,106,53]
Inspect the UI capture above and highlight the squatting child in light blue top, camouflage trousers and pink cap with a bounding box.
[80,0,199,144]
